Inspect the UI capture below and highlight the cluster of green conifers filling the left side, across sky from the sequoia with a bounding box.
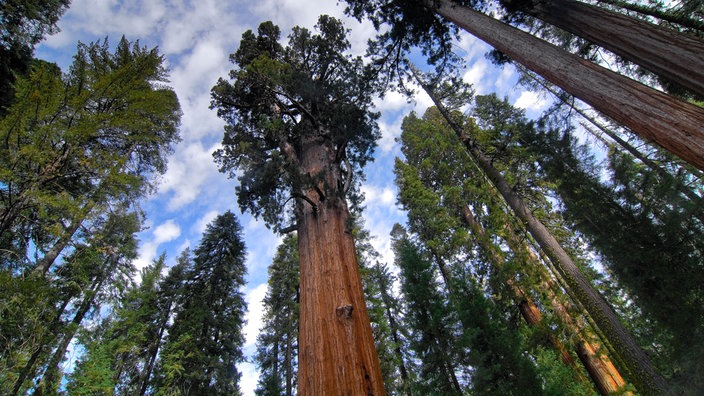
[0,0,246,395]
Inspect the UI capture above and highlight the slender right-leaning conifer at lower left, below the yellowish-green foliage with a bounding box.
[7,210,140,395]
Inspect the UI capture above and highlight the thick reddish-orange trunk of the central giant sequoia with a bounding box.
[297,135,385,396]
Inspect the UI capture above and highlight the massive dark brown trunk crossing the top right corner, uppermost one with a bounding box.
[519,0,704,95]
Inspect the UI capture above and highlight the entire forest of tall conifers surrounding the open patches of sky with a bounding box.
[0,0,704,396]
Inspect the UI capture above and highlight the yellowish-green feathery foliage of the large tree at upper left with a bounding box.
[0,38,180,271]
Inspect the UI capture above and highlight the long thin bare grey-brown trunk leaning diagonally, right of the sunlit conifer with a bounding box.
[416,69,671,395]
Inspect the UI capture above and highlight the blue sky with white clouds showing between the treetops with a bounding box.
[36,0,547,395]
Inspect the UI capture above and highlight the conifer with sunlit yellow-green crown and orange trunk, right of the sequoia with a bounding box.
[394,103,625,394]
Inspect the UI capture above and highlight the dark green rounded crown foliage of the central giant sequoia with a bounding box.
[211,16,379,228]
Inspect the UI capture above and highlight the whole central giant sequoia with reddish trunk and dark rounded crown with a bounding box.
[212,16,384,395]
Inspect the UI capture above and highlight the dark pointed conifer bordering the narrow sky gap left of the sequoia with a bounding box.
[158,211,246,395]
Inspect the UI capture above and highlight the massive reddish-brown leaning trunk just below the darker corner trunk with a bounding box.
[426,0,704,170]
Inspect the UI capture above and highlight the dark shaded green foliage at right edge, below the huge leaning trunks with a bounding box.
[522,125,704,387]
